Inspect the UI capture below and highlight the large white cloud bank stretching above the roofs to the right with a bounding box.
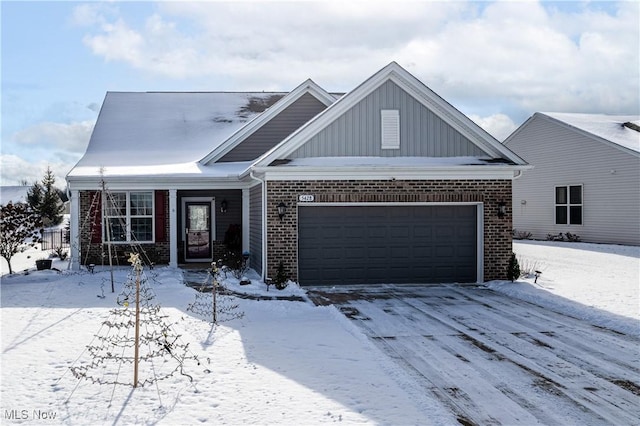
[76,2,640,120]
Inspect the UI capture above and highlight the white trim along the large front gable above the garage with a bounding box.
[254,62,527,166]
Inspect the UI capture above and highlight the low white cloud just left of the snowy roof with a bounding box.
[12,120,95,153]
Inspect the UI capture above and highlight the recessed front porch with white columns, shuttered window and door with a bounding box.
[71,189,249,267]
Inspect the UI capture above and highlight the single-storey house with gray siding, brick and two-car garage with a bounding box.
[67,62,530,285]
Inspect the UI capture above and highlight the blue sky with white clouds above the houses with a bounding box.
[0,0,640,187]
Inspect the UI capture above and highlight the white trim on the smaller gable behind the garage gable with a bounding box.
[199,79,336,164]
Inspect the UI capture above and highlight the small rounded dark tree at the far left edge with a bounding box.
[0,203,42,274]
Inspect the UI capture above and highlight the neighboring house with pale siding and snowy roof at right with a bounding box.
[504,112,640,245]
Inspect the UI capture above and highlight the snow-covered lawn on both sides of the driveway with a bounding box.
[0,242,640,424]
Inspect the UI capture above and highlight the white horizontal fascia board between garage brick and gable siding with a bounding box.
[254,166,531,181]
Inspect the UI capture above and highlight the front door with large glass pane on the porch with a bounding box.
[185,202,212,262]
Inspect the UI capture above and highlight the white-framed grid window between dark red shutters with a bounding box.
[104,191,153,243]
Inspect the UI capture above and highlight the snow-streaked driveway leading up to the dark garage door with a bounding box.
[308,285,640,425]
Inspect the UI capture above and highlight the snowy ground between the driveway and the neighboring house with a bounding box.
[500,241,640,335]
